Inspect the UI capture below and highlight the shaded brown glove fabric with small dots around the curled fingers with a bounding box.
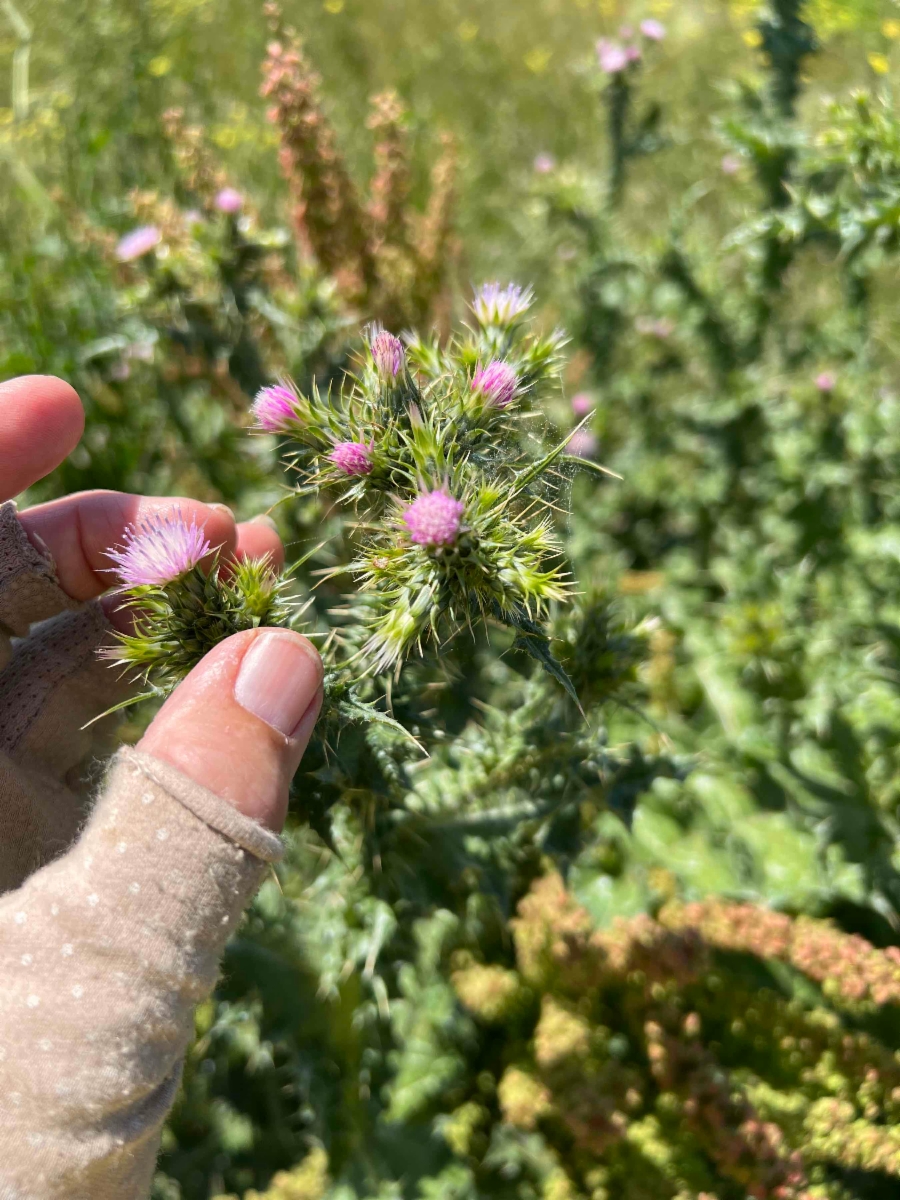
[0,503,126,893]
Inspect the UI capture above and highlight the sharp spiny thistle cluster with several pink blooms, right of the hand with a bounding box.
[253,284,588,680]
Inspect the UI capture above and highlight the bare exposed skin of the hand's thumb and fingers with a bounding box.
[0,376,322,832]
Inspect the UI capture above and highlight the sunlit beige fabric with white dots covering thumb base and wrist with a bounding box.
[0,750,281,1200]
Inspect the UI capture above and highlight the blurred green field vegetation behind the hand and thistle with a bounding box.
[12,0,900,1200]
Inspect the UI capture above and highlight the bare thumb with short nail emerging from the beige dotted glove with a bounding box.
[138,629,323,833]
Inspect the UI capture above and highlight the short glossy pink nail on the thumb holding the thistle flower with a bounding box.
[234,632,322,737]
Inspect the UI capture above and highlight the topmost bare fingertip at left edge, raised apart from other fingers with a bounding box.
[0,376,84,502]
